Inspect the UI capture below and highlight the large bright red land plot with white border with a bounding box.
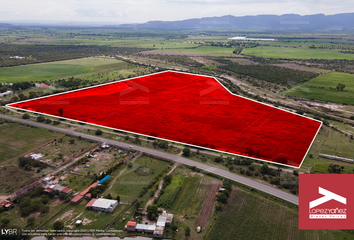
[7,71,322,167]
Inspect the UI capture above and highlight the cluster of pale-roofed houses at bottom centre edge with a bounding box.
[124,211,173,238]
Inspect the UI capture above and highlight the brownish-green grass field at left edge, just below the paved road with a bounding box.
[0,123,62,165]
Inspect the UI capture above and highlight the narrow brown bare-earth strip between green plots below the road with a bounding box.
[195,180,220,227]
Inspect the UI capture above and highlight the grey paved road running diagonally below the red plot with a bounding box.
[0,114,299,205]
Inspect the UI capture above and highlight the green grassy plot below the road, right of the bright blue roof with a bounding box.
[105,155,170,203]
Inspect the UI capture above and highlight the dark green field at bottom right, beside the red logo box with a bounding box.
[208,190,354,240]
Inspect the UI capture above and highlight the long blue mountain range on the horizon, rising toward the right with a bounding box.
[112,13,354,31]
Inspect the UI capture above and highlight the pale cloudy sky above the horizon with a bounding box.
[0,0,354,23]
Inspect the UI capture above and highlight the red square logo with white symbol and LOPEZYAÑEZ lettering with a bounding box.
[299,174,354,229]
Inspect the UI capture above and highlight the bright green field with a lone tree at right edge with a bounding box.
[285,72,354,104]
